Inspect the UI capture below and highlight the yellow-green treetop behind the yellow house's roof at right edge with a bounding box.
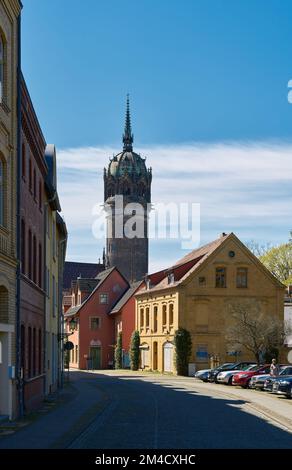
[260,240,292,286]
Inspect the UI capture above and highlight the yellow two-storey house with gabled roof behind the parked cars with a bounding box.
[136,234,285,373]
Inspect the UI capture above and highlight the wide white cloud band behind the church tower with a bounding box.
[57,142,292,268]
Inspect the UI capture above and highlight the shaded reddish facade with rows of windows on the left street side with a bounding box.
[20,78,47,411]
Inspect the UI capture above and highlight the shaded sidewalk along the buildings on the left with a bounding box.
[0,372,108,449]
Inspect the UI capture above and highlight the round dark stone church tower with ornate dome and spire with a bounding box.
[104,96,152,282]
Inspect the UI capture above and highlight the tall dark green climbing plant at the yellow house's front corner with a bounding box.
[174,328,192,375]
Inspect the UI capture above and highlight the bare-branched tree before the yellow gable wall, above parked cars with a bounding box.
[226,301,290,364]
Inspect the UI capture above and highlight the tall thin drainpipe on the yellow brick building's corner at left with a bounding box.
[15,9,24,417]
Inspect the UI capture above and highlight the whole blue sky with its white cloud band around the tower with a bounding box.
[22,0,292,269]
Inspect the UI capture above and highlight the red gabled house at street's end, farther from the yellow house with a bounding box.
[64,268,129,369]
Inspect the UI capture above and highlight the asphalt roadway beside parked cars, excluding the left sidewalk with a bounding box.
[69,372,292,449]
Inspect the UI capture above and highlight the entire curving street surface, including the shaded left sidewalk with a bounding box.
[0,371,292,449]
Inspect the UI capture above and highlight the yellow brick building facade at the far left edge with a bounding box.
[0,0,21,418]
